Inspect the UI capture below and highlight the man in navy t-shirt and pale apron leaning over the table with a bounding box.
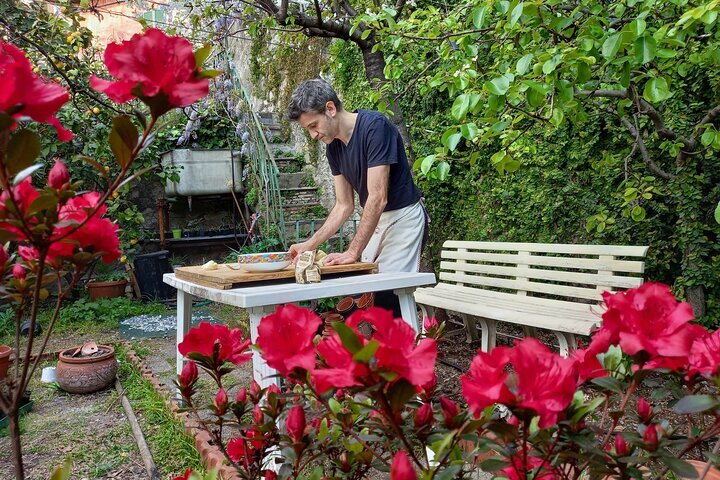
[288,79,426,315]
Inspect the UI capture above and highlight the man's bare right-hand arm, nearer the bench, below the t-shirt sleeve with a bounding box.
[325,165,390,265]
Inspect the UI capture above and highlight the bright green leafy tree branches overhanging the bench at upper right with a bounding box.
[356,0,720,315]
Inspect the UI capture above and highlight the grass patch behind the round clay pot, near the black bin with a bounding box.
[0,297,169,345]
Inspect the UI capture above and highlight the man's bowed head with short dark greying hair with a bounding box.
[288,78,343,144]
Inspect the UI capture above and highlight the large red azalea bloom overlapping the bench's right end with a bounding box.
[601,283,706,370]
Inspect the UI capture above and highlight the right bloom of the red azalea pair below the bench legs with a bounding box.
[510,338,578,428]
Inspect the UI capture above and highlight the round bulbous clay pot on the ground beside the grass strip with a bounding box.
[55,345,117,393]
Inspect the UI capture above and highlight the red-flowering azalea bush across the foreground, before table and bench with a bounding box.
[178,283,720,480]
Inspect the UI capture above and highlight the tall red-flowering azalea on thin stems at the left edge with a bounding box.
[0,29,217,480]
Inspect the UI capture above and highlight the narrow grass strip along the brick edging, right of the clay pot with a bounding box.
[116,346,202,476]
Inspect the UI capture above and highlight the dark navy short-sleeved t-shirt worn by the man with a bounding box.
[327,110,420,212]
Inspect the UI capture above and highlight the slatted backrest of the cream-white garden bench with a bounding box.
[440,240,648,301]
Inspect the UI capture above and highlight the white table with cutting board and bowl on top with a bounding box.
[163,273,435,387]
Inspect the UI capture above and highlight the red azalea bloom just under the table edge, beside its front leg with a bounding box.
[257,305,322,376]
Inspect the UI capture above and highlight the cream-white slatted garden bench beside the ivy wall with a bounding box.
[415,240,648,356]
